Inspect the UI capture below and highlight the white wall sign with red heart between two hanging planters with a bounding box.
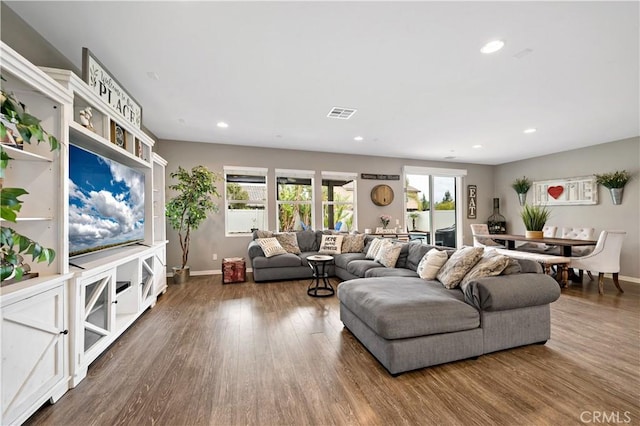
[533,176,598,206]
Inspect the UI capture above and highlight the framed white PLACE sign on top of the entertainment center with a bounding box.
[82,47,142,128]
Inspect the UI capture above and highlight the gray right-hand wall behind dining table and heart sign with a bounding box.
[494,137,640,279]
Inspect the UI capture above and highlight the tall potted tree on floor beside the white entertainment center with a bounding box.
[166,166,220,284]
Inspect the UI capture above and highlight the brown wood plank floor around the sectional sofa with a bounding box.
[27,275,640,426]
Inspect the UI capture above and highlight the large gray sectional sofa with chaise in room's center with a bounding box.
[249,231,560,375]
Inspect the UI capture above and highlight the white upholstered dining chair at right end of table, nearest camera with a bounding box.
[569,231,627,294]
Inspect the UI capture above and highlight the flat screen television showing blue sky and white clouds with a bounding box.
[69,145,144,257]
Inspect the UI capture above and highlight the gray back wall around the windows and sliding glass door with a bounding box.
[156,140,494,271]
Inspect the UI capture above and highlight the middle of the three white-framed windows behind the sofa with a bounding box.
[276,169,315,232]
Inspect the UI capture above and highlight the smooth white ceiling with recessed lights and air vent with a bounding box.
[6,1,640,164]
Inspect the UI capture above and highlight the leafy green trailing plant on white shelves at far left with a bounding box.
[0,83,60,281]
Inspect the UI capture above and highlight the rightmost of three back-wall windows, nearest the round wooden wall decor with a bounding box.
[322,172,358,232]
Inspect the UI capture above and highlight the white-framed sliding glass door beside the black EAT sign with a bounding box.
[404,166,467,247]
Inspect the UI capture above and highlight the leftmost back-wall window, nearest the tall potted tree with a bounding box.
[224,166,268,236]
